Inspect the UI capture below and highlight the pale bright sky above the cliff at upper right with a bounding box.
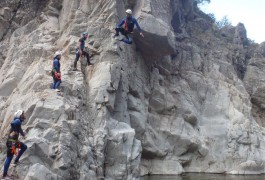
[200,0,265,43]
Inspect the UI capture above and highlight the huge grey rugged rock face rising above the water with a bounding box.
[0,0,265,180]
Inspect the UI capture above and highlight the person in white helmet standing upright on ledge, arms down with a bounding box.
[52,51,62,92]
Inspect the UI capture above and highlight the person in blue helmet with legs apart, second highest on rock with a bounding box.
[74,32,93,71]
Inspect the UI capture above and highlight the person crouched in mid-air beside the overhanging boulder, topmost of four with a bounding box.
[114,9,144,44]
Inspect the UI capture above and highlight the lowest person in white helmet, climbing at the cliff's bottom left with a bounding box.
[3,110,27,179]
